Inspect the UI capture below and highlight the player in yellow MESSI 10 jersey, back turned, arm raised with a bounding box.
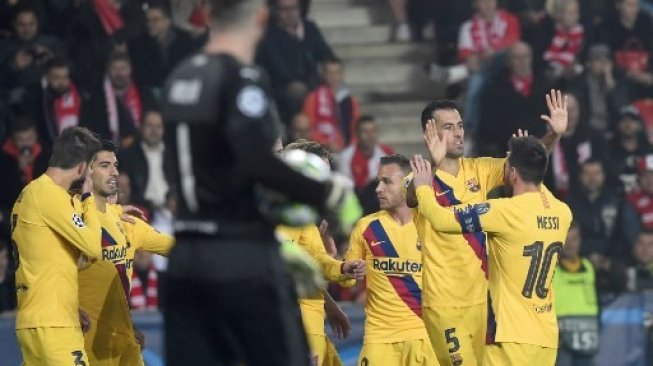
[412,136,572,366]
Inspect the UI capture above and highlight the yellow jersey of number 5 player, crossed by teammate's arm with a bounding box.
[415,158,505,307]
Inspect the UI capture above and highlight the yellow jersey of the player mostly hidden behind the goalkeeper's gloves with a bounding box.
[277,225,356,335]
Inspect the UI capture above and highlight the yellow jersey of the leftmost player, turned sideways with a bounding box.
[11,174,101,329]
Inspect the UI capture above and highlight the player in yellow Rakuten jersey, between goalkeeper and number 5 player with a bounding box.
[345,155,439,366]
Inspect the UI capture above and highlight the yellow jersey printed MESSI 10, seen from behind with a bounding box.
[417,185,572,348]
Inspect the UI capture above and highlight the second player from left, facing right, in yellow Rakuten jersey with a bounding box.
[79,141,174,366]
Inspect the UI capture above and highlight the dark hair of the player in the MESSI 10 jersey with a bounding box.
[508,136,549,184]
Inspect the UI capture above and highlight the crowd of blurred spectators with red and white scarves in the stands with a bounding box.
[0,0,653,364]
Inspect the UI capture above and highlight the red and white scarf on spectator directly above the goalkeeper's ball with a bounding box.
[311,85,344,151]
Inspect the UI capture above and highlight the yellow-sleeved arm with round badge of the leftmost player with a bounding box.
[38,173,102,260]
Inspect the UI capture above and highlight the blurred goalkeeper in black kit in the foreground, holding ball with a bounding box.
[164,0,360,366]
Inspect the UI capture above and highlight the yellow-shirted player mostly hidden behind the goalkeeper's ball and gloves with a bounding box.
[277,140,365,366]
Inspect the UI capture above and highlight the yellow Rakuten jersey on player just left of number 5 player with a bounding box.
[345,211,428,343]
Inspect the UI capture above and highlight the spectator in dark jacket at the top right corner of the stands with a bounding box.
[601,0,653,98]
